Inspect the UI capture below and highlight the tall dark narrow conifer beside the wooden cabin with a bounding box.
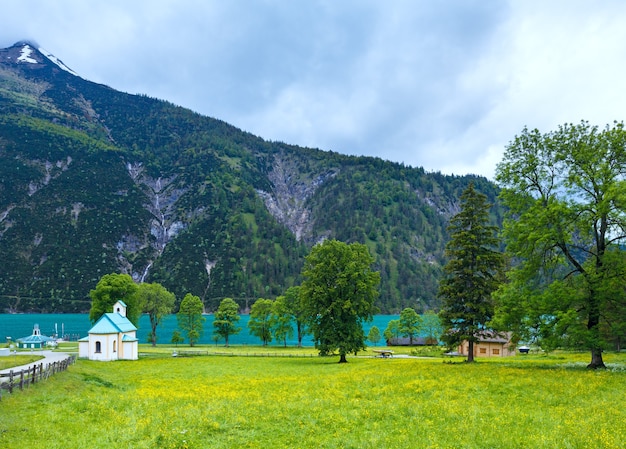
[439,184,503,362]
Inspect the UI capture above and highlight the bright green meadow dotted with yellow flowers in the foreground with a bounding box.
[0,347,626,449]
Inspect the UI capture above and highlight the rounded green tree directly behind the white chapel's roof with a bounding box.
[89,273,143,327]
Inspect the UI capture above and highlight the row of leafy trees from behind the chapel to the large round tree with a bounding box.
[90,240,378,362]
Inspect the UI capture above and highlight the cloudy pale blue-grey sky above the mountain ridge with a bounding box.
[0,0,626,179]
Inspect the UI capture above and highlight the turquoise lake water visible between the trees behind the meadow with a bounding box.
[0,313,398,346]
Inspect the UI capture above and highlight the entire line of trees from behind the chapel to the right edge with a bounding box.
[90,121,626,368]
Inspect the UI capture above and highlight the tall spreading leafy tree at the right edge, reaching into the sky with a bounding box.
[496,122,626,368]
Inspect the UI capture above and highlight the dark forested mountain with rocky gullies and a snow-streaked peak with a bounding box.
[0,42,501,313]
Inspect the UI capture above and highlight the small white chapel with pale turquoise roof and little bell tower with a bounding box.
[78,301,139,362]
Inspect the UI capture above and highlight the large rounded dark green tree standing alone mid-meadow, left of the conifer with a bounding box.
[300,240,380,363]
